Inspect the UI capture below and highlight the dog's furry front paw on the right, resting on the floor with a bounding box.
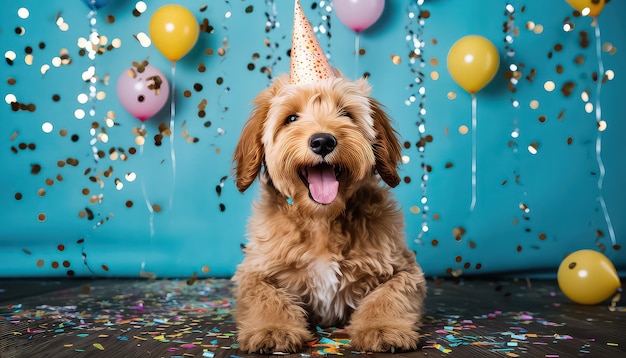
[349,327,419,353]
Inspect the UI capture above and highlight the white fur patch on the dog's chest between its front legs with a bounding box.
[309,259,345,325]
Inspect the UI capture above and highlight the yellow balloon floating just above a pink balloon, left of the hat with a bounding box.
[148,4,199,62]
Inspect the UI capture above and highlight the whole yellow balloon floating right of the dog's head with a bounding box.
[447,35,500,94]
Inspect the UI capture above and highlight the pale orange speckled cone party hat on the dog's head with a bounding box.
[289,0,335,84]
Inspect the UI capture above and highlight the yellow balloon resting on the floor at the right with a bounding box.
[557,250,621,305]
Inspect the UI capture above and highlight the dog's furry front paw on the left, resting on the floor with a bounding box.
[239,327,312,354]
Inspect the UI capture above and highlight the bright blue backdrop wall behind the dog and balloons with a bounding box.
[0,0,626,277]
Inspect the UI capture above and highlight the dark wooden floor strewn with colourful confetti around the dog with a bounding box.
[0,278,626,358]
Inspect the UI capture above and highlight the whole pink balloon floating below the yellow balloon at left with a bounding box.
[117,65,170,122]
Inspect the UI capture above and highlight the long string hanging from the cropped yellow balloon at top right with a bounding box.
[594,18,616,245]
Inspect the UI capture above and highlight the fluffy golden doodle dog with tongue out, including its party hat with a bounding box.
[233,1,426,353]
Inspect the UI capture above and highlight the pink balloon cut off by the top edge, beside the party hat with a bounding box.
[333,0,385,32]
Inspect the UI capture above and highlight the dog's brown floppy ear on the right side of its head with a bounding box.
[370,99,402,188]
